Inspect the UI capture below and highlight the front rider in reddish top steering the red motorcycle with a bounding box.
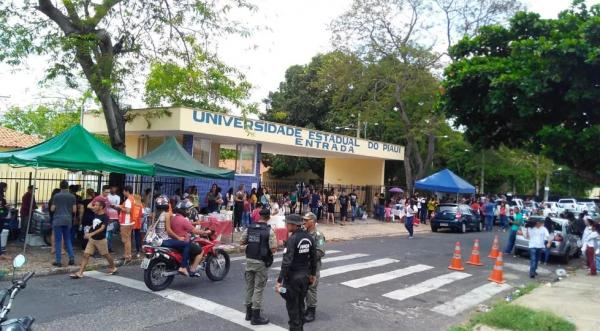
[171,199,212,277]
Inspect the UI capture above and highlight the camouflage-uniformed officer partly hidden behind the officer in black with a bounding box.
[302,213,325,323]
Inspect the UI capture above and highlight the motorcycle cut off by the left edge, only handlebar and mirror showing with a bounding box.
[0,254,35,331]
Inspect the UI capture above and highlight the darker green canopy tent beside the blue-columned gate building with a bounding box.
[139,137,235,180]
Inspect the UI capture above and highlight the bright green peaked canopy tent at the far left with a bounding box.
[0,125,155,252]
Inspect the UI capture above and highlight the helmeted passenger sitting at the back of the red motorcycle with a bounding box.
[154,195,190,276]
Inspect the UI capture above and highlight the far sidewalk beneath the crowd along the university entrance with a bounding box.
[0,219,431,280]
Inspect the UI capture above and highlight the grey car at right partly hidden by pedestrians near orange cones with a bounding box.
[515,216,581,264]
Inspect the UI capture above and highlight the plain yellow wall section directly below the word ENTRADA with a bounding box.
[323,158,385,185]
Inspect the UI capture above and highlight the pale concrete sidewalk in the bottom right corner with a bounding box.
[513,269,600,331]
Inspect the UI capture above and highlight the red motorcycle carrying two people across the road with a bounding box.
[141,232,230,291]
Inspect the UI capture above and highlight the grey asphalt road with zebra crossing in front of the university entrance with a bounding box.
[1,232,577,330]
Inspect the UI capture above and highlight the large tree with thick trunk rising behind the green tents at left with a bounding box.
[0,0,254,151]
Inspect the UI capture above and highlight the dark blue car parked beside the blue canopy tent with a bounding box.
[431,203,483,233]
